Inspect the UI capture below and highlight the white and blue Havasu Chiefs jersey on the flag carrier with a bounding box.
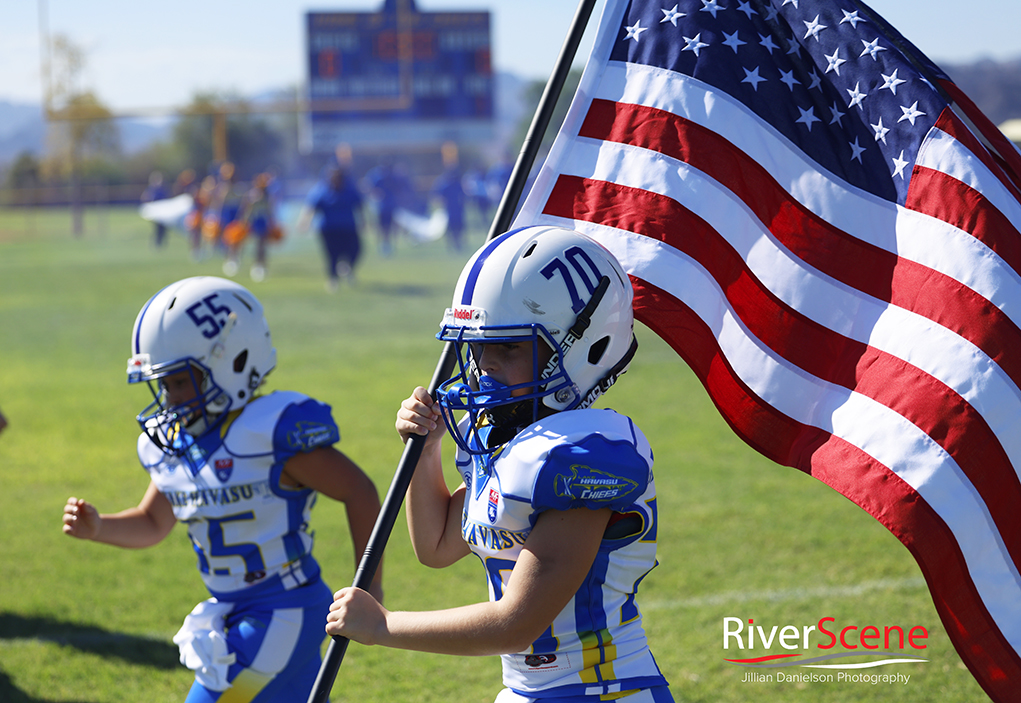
[456,409,667,698]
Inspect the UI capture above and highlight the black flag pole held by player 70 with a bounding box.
[307,0,595,703]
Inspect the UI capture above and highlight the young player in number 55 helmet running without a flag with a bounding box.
[63,277,383,703]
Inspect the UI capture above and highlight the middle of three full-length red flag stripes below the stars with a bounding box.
[543,175,1021,563]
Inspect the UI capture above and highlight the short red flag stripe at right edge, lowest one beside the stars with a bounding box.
[904,165,1021,271]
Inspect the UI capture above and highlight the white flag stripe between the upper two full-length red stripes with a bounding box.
[540,139,1021,471]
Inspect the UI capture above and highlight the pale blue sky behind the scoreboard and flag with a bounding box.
[0,0,1021,109]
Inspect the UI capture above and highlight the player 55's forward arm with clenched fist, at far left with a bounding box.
[63,482,177,549]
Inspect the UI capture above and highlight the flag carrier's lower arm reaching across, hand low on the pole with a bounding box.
[327,508,611,655]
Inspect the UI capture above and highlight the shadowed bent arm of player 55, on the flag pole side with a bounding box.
[281,447,383,602]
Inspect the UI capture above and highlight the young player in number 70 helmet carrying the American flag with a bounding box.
[327,227,673,703]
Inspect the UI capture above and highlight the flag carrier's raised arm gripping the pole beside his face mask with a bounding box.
[396,386,469,568]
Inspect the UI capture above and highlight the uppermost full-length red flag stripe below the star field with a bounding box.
[579,100,1021,386]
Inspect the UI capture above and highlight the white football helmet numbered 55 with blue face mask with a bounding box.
[128,275,277,456]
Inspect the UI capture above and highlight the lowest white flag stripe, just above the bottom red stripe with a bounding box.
[539,224,1021,649]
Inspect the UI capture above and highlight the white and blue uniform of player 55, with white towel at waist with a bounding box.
[138,391,340,703]
